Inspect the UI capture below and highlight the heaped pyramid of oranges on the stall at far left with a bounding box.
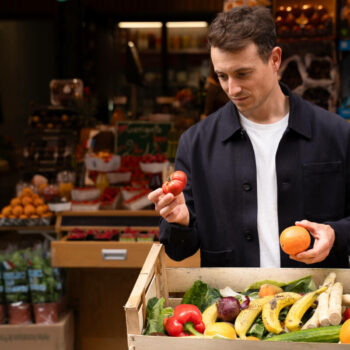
[0,187,53,226]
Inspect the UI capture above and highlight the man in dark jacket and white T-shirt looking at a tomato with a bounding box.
[149,7,350,267]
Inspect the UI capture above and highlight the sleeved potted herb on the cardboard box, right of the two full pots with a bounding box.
[28,251,62,324]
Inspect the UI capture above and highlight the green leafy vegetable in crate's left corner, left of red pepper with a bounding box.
[143,298,174,335]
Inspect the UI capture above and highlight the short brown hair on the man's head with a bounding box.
[208,6,277,61]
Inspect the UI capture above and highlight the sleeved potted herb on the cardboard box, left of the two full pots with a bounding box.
[2,250,32,324]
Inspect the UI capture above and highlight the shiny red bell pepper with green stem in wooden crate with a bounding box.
[165,304,205,337]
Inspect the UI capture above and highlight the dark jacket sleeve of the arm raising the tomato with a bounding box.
[160,129,199,261]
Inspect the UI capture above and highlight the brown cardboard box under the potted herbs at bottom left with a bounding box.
[0,312,74,350]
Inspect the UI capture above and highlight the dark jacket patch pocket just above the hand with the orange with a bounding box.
[303,161,345,222]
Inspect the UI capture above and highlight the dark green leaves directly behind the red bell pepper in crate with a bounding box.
[181,280,221,312]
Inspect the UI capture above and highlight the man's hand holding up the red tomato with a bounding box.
[148,188,190,226]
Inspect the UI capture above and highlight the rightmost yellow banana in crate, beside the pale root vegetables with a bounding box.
[285,286,327,331]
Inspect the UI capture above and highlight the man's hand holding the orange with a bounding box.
[289,220,335,264]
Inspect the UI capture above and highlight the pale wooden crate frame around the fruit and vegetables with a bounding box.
[124,244,350,350]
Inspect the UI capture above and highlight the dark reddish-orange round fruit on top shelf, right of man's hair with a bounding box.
[275,3,333,38]
